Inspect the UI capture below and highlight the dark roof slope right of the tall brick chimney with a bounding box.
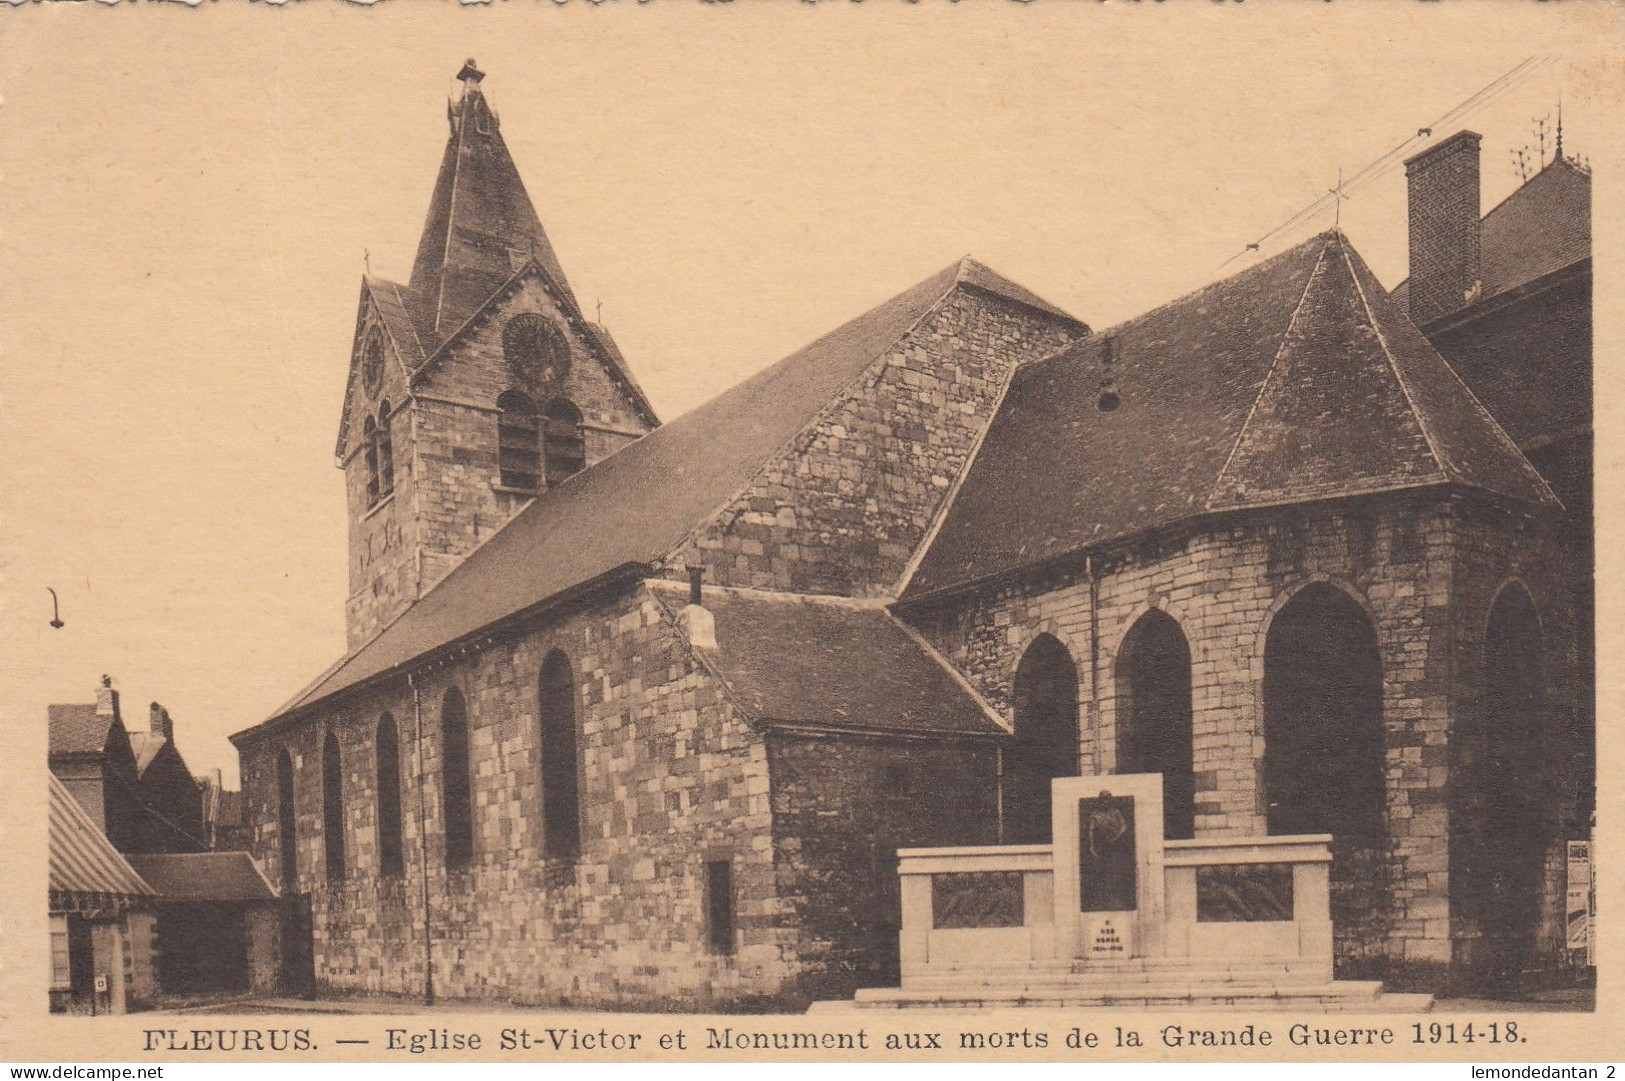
[1393,158,1591,315]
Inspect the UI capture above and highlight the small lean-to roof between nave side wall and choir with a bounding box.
[648,580,1008,735]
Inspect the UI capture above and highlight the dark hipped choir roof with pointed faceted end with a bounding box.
[905,232,1554,598]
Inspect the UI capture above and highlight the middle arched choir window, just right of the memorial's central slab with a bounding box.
[1116,610,1196,840]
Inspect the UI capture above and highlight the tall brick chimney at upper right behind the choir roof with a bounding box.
[1406,132,1482,327]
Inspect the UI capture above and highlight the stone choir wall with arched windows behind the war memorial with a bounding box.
[905,494,1565,987]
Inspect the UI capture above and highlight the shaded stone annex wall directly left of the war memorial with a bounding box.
[767,732,999,1001]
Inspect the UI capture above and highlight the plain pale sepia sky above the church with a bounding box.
[0,0,1625,784]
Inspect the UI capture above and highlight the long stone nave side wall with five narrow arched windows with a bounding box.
[241,590,796,1008]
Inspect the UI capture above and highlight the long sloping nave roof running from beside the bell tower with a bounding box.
[247,257,1076,728]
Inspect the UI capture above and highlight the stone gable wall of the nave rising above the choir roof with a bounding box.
[668,288,1082,597]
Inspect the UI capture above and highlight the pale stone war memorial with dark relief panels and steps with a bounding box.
[821,774,1433,1011]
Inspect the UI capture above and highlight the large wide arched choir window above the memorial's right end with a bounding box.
[1264,582,1389,979]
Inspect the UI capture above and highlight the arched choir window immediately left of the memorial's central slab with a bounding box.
[1004,634,1079,844]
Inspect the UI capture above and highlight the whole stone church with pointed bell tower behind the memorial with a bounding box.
[232,62,1594,1009]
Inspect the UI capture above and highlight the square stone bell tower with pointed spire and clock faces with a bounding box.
[336,60,660,649]
